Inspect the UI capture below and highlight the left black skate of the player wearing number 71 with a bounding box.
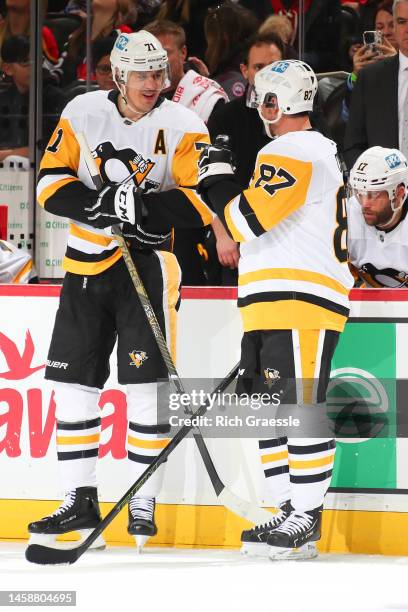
[28,487,105,549]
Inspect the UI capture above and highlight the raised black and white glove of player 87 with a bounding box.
[197,135,234,193]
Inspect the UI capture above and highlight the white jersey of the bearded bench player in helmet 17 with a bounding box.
[347,197,408,288]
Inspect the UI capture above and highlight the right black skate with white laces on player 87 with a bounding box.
[267,506,323,559]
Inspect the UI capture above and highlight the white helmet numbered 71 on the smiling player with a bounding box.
[110,30,170,91]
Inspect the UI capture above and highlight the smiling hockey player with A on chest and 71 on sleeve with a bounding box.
[29,31,213,547]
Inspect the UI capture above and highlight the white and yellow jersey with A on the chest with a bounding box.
[37,91,213,275]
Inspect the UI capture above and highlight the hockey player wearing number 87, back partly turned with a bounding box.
[199,60,353,559]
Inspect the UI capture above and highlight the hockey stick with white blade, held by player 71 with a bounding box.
[76,132,271,524]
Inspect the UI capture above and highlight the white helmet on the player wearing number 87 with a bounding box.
[247,60,317,123]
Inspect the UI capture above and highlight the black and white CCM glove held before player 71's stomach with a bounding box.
[85,183,147,229]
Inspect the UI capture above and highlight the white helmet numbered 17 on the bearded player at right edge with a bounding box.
[349,147,408,211]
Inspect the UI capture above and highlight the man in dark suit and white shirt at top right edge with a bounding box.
[344,0,408,168]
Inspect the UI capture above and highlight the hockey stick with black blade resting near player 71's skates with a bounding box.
[25,365,239,565]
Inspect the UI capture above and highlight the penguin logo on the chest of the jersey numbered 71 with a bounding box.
[95,142,160,193]
